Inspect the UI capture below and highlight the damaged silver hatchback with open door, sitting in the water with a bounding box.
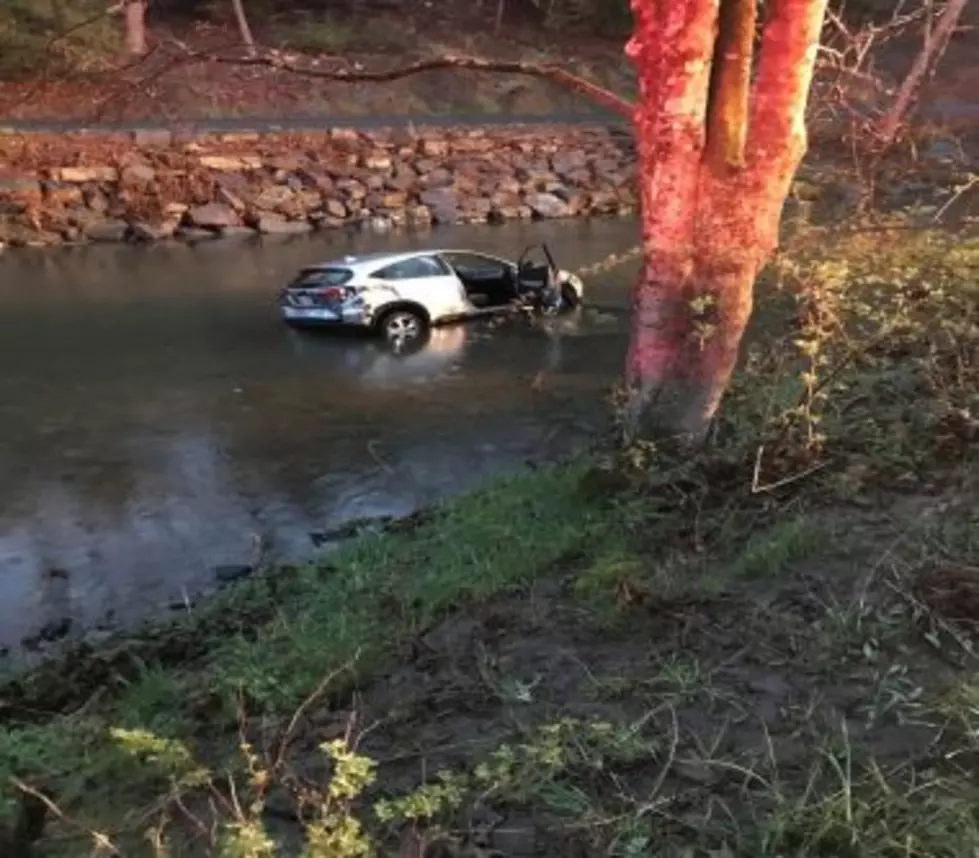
[279,244,584,344]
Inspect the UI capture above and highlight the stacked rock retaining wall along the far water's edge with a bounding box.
[0,127,636,246]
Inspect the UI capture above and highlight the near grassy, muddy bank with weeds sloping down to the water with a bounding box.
[0,206,979,858]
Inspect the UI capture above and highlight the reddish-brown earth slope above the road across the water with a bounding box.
[0,3,631,121]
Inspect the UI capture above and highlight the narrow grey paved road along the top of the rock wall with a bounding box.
[0,111,628,133]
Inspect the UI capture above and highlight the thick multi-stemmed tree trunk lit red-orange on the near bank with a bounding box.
[624,0,826,441]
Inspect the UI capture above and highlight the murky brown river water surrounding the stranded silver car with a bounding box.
[0,220,637,655]
